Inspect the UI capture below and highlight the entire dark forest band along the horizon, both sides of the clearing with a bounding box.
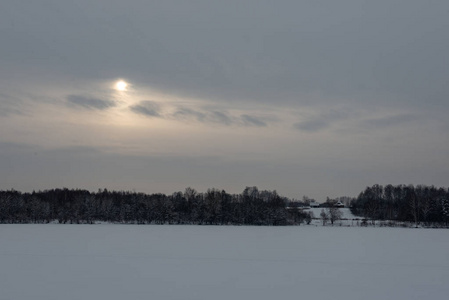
[0,185,449,227]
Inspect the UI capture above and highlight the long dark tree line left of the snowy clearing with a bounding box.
[0,187,308,225]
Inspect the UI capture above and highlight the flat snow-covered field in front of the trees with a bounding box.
[0,224,449,300]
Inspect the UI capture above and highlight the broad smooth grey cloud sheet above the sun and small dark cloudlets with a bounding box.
[0,0,449,112]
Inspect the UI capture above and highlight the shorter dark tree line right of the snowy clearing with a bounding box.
[351,184,449,226]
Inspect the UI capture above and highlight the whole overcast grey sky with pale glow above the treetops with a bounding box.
[0,0,449,201]
